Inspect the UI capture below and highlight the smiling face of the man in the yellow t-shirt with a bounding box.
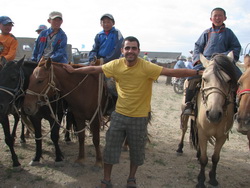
[122,41,140,62]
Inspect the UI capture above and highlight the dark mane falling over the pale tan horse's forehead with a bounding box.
[212,54,238,88]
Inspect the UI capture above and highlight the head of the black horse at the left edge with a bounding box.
[0,58,24,114]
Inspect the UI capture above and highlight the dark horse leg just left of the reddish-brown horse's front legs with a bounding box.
[49,118,64,162]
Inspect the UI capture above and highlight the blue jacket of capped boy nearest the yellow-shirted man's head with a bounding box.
[89,27,123,63]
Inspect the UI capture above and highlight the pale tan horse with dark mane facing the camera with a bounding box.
[180,53,237,187]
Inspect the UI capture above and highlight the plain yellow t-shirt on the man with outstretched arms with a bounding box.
[102,58,162,117]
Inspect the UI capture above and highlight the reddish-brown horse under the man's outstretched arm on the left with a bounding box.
[24,59,107,167]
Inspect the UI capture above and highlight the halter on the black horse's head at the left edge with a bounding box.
[0,69,25,109]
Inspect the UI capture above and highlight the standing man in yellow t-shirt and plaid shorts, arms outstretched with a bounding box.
[64,36,202,188]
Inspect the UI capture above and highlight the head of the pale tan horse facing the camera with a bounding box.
[200,53,237,123]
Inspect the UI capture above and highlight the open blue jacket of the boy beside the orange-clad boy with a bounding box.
[31,28,68,63]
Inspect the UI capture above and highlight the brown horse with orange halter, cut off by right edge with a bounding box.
[236,55,250,149]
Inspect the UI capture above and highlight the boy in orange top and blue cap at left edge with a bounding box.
[0,16,18,61]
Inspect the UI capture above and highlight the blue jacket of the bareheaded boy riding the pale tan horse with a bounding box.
[193,24,241,64]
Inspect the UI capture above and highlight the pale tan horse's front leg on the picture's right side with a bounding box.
[208,135,227,186]
